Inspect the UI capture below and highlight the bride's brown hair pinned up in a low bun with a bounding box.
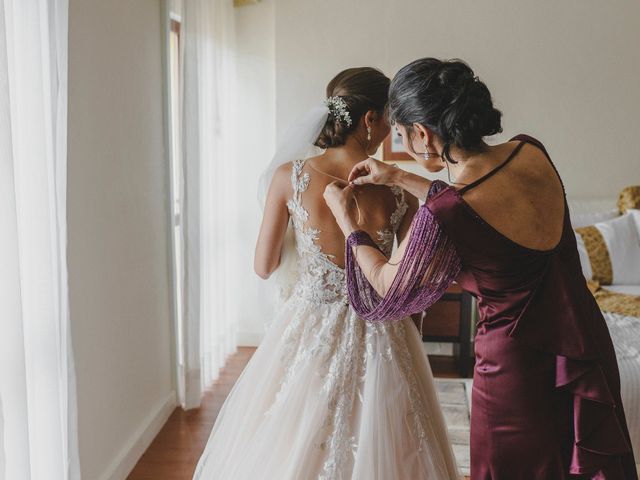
[316,67,391,148]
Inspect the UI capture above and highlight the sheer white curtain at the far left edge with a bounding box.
[0,0,80,480]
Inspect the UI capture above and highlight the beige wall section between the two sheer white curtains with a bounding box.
[68,0,174,480]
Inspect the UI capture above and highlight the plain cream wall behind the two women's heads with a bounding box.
[275,0,640,197]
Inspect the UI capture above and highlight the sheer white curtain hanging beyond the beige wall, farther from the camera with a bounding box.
[178,0,242,409]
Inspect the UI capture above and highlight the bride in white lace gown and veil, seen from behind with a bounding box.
[194,68,460,480]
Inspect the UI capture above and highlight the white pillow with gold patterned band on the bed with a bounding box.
[575,212,640,285]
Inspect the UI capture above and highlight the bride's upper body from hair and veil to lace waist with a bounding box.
[254,67,408,284]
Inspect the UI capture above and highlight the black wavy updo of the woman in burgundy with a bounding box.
[388,58,502,163]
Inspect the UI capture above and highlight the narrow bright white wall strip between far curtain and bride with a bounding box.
[235,0,276,345]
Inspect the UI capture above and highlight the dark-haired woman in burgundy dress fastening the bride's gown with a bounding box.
[325,58,638,480]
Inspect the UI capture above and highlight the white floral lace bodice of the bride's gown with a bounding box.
[287,160,408,304]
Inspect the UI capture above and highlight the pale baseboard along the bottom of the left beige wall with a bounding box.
[100,390,177,480]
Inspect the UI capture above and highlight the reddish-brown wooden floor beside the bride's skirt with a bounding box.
[127,347,468,480]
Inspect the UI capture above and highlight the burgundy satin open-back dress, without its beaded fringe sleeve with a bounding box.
[427,135,638,480]
